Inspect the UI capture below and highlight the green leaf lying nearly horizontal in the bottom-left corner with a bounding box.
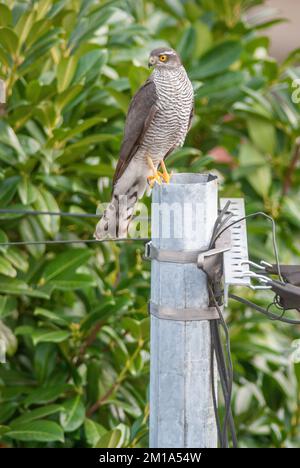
[5,420,64,442]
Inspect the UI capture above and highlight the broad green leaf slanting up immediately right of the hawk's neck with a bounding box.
[190,41,243,80]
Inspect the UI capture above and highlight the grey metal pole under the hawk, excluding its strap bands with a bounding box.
[150,174,218,448]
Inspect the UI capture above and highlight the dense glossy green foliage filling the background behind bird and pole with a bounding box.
[0,0,300,447]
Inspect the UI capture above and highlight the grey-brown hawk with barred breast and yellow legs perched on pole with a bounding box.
[94,47,194,240]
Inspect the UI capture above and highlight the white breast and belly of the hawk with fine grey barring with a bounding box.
[137,66,193,166]
